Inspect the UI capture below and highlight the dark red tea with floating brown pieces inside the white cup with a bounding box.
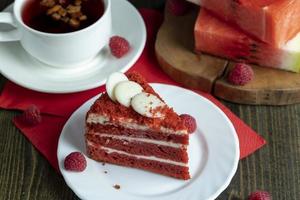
[22,0,104,33]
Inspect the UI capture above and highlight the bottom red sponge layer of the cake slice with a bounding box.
[87,146,190,180]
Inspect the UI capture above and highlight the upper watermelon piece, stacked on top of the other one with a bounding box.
[189,0,300,47]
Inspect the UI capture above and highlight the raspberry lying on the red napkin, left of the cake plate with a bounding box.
[19,105,42,126]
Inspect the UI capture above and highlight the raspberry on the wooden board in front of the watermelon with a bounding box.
[227,63,254,85]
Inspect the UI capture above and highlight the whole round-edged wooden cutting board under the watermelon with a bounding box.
[155,7,300,105]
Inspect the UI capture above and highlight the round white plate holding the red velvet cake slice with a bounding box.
[57,84,239,200]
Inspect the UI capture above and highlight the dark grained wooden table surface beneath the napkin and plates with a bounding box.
[0,0,300,200]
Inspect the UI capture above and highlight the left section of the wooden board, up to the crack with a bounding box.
[155,9,228,93]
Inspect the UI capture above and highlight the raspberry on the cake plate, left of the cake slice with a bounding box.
[64,152,86,172]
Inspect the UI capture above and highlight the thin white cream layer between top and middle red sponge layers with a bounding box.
[93,132,186,148]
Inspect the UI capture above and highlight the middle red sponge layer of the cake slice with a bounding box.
[86,134,188,163]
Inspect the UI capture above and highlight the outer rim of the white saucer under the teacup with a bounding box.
[0,0,147,94]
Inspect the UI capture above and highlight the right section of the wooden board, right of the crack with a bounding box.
[214,63,300,105]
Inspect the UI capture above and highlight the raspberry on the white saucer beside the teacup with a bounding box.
[109,36,130,58]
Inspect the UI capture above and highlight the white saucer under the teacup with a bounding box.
[0,0,146,93]
